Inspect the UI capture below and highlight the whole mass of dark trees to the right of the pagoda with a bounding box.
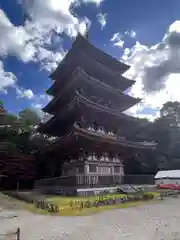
[125,102,180,174]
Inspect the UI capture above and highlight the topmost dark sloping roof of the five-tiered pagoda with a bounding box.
[51,34,130,79]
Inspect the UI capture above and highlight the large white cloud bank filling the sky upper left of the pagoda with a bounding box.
[0,0,93,71]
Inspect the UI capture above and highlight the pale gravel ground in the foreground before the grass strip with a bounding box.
[0,198,180,240]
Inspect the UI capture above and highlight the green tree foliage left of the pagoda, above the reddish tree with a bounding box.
[0,103,49,153]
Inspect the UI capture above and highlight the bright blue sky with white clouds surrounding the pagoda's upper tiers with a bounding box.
[0,0,180,120]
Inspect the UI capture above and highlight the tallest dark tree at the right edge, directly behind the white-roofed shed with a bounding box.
[148,102,180,169]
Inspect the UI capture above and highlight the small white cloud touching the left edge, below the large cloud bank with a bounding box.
[0,61,17,92]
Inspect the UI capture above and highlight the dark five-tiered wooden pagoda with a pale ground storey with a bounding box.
[38,35,156,195]
